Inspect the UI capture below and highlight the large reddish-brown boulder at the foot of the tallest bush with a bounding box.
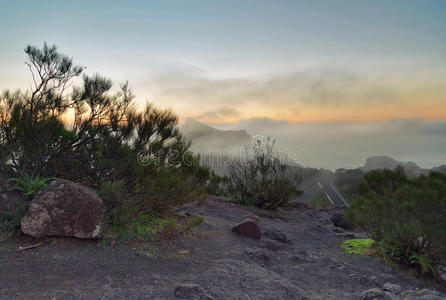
[21,179,105,239]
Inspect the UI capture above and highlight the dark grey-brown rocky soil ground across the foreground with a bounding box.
[0,197,446,299]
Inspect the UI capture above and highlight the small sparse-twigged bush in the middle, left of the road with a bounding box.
[227,138,302,209]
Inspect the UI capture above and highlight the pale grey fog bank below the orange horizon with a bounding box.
[210,118,446,170]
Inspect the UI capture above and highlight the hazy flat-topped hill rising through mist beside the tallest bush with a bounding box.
[181,118,251,152]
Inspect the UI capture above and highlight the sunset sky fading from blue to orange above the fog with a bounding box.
[0,0,446,123]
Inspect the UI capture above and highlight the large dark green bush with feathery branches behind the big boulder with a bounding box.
[0,44,210,229]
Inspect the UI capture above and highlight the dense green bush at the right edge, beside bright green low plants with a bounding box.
[346,168,446,273]
